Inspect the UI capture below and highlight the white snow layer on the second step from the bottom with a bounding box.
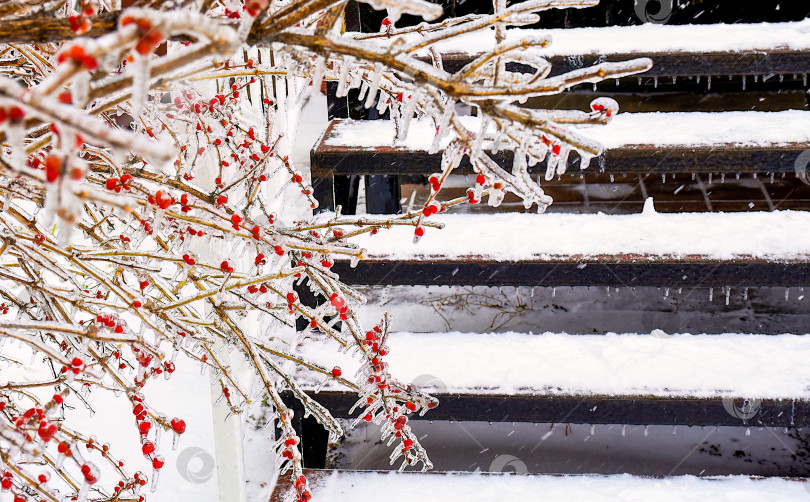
[302,332,810,400]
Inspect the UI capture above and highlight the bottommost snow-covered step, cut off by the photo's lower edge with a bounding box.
[271,468,810,502]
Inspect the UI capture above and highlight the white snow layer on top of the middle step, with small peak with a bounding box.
[326,209,810,264]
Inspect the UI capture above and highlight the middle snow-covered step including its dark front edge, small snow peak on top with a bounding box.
[334,209,810,286]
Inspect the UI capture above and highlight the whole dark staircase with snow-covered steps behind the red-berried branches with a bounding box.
[274,0,810,501]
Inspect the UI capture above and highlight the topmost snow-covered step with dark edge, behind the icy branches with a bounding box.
[414,20,810,81]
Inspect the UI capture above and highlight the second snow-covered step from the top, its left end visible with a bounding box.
[312,112,810,178]
